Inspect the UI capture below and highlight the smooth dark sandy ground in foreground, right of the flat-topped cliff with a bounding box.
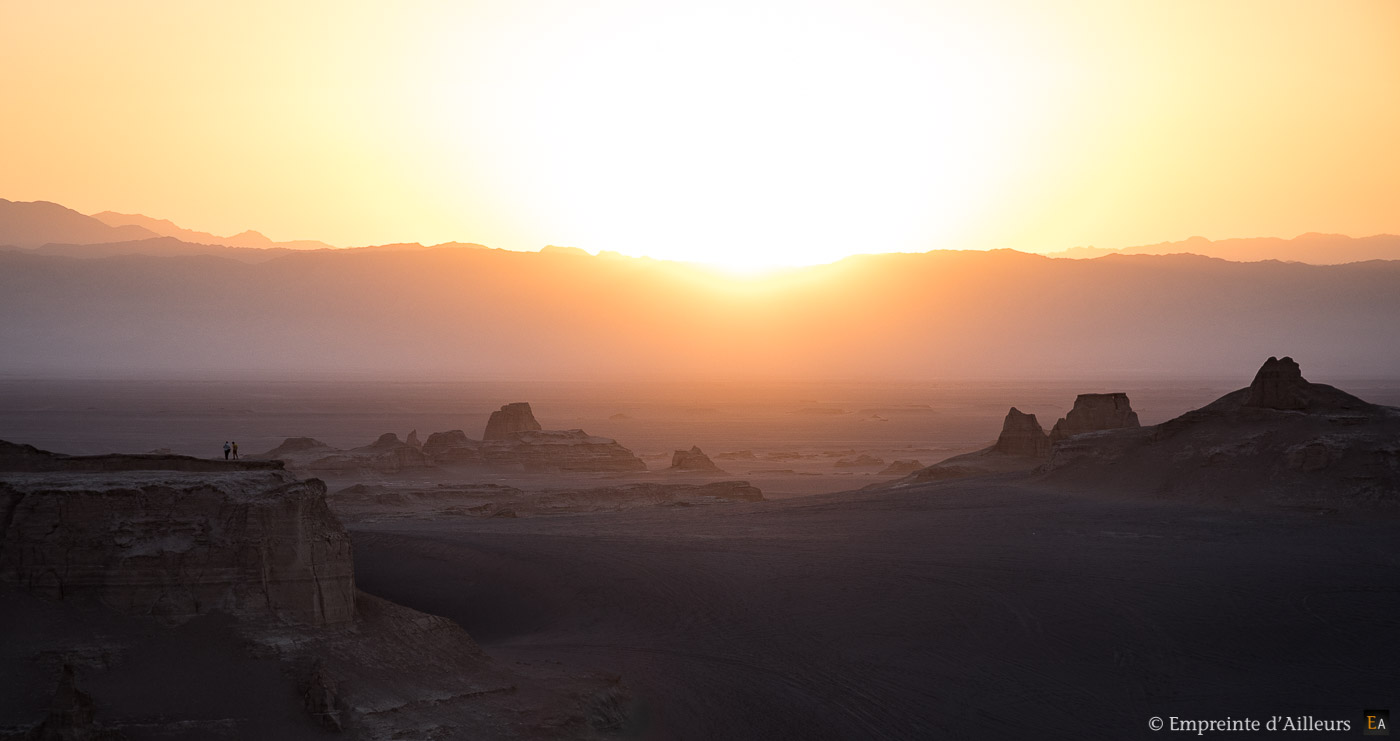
[353,479,1400,738]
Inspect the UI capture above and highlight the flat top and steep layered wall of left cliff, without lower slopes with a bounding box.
[0,444,354,626]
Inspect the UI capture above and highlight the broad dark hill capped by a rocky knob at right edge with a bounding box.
[1044,357,1400,507]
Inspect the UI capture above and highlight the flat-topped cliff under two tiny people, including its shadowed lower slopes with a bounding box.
[0,440,635,741]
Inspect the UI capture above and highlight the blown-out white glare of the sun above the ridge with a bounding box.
[448,3,1069,267]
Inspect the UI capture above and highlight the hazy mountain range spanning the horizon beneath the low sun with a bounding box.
[0,194,1400,378]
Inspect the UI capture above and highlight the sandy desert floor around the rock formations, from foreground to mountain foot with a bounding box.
[0,380,1400,740]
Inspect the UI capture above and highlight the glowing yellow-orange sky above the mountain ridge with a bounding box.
[0,0,1400,263]
